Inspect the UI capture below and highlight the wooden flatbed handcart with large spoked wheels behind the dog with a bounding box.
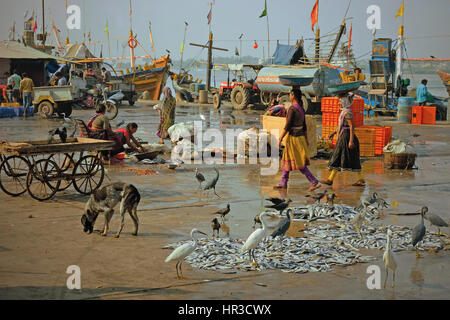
[0,138,114,201]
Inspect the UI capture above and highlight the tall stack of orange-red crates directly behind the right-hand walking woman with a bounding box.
[321,97,364,147]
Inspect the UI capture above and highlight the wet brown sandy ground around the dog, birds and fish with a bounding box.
[0,105,450,300]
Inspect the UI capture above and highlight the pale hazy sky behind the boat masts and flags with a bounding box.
[0,0,450,59]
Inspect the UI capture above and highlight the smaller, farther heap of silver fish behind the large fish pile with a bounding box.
[291,203,378,221]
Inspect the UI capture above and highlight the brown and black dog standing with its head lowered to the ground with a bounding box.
[81,182,141,238]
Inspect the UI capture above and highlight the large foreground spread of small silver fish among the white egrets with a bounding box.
[165,223,444,273]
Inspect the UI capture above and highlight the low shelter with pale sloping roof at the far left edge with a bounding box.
[0,40,67,86]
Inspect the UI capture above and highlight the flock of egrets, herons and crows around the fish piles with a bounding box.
[166,175,448,288]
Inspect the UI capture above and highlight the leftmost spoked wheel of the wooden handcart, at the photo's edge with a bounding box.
[0,156,30,197]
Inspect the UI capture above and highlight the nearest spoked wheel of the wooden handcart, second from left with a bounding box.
[27,159,61,201]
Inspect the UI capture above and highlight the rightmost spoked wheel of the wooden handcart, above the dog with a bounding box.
[73,156,105,194]
